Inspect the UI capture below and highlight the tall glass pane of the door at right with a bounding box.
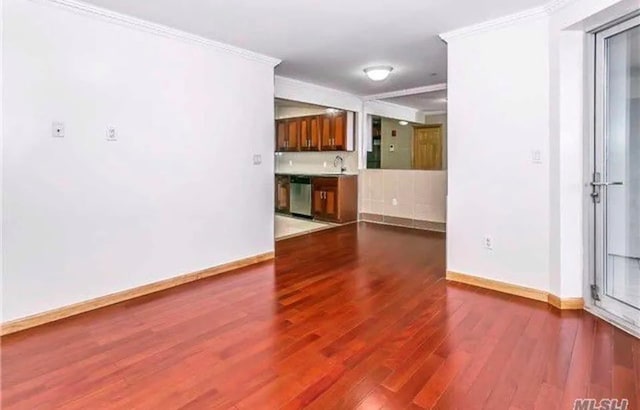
[605,26,640,307]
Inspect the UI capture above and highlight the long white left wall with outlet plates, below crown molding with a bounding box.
[2,0,274,320]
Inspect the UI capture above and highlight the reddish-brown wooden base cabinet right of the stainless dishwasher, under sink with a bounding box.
[312,175,358,223]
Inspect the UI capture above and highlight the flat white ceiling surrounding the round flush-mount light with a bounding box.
[77,0,547,95]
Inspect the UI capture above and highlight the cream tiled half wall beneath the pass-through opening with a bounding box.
[359,169,447,231]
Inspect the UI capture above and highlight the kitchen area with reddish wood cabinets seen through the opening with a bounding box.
[275,99,358,240]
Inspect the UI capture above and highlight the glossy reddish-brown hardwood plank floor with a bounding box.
[2,223,640,409]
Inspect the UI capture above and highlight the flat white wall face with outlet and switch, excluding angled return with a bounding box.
[447,16,549,290]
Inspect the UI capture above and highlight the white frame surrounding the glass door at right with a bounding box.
[584,13,640,337]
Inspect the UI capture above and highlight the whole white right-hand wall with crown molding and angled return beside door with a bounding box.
[442,0,638,298]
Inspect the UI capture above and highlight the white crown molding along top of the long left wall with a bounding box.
[32,0,281,67]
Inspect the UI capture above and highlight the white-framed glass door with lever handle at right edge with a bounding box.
[591,17,640,333]
